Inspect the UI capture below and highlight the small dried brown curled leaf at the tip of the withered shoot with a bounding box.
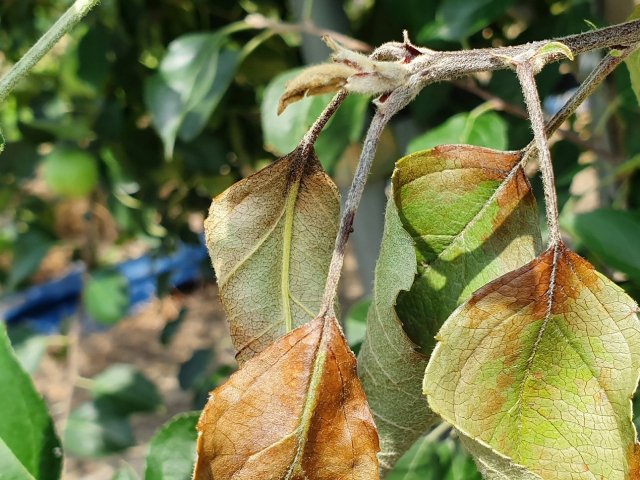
[278,63,358,115]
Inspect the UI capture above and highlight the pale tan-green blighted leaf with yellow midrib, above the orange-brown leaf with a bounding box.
[205,144,340,364]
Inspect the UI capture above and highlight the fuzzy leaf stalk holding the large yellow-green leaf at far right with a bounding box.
[516,60,562,248]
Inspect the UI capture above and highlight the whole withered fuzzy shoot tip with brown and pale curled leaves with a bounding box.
[278,37,410,115]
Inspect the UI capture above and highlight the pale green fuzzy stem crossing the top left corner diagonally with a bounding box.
[0,0,99,102]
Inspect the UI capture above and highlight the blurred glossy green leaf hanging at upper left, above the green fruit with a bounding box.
[145,33,241,158]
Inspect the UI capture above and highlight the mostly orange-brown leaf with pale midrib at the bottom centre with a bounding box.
[193,317,379,480]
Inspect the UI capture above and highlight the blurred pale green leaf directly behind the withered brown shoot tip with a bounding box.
[260,68,369,171]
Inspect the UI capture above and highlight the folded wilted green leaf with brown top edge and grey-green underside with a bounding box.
[358,145,541,469]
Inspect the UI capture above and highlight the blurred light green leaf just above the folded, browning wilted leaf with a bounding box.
[407,105,508,154]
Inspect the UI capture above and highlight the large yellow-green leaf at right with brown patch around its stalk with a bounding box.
[424,244,640,480]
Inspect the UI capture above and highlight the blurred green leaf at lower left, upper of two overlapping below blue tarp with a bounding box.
[91,363,162,415]
